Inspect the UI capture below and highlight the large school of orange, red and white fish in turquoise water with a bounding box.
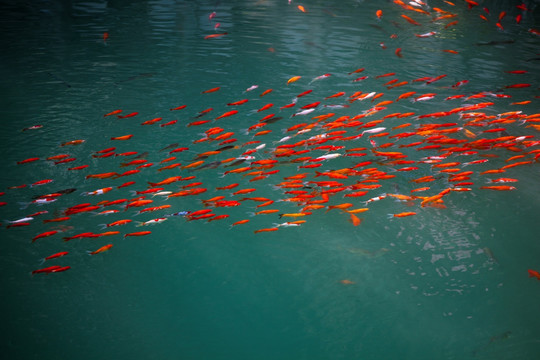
[0,0,540,280]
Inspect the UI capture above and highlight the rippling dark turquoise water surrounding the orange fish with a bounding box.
[0,0,540,360]
